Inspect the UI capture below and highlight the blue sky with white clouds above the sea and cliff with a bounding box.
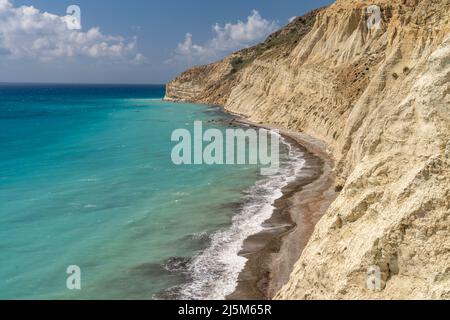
[0,0,333,84]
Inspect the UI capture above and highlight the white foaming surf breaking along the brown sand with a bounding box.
[169,133,305,300]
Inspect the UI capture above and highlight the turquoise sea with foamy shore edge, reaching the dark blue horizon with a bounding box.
[0,85,304,299]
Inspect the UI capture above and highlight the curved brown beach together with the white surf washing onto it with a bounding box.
[151,105,337,300]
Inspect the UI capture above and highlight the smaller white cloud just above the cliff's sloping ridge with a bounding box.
[168,10,279,63]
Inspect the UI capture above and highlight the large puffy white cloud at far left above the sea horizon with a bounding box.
[0,0,146,63]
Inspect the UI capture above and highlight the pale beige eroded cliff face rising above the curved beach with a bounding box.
[167,0,450,299]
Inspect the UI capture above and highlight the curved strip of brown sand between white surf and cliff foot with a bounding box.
[227,120,337,300]
